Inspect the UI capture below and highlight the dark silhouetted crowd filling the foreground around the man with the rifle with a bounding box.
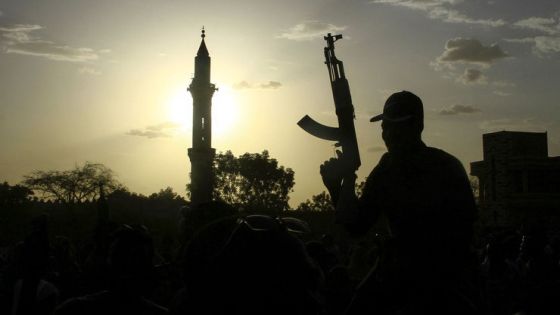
[0,203,560,315]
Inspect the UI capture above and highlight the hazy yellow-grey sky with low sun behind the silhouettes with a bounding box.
[0,0,560,206]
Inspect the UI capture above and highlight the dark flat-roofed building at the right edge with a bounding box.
[471,131,560,226]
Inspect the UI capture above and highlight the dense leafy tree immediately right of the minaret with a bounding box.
[213,150,294,212]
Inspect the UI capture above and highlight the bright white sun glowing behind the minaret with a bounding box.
[167,84,238,137]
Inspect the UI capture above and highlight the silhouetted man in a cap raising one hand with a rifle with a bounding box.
[321,91,476,314]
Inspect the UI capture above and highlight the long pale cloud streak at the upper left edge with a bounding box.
[0,24,99,62]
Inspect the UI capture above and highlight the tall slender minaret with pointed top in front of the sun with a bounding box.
[188,27,216,206]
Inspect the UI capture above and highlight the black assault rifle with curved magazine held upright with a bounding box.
[298,33,361,171]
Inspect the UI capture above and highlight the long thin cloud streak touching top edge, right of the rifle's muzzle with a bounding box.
[370,0,507,27]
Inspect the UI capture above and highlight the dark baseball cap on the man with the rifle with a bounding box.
[369,91,424,122]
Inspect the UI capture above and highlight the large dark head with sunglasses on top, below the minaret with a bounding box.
[184,215,321,315]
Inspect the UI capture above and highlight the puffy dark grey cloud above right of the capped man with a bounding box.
[436,37,509,66]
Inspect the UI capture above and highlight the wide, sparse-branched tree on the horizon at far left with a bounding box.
[22,162,123,203]
